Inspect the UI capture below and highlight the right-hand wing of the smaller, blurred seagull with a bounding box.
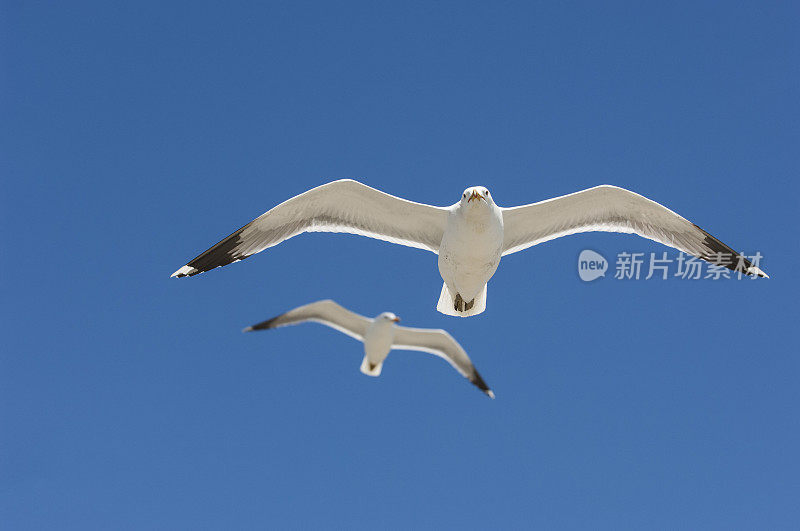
[392,326,494,398]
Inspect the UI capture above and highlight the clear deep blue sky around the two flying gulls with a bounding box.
[0,1,800,529]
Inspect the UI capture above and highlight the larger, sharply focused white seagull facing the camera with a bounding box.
[172,179,768,317]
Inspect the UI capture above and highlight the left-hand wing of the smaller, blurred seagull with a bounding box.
[243,299,372,341]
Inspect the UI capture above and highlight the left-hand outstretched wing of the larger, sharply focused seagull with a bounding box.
[172,179,448,277]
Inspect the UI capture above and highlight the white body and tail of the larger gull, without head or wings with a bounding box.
[439,204,503,316]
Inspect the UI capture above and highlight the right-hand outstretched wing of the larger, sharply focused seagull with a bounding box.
[503,185,767,277]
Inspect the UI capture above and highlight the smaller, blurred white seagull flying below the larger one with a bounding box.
[243,299,494,398]
